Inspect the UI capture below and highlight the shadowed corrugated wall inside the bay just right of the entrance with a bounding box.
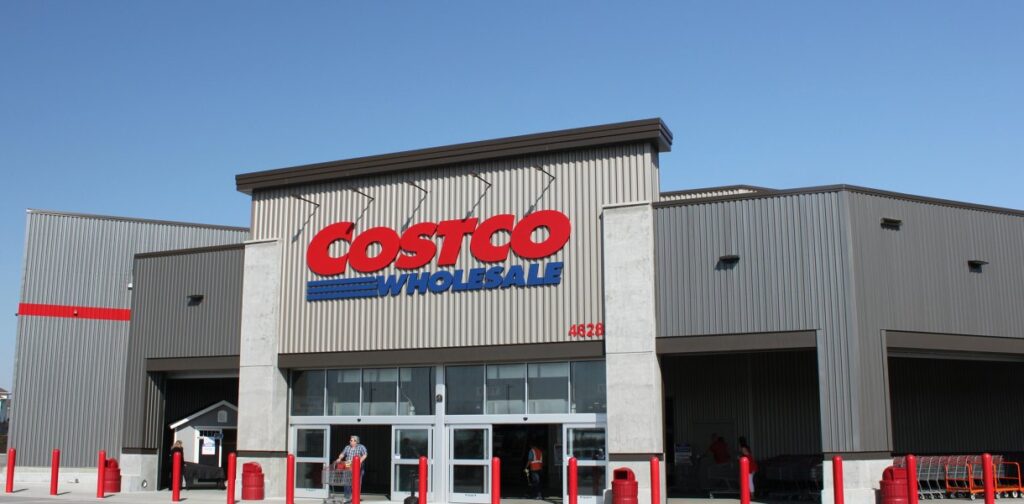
[662,350,821,460]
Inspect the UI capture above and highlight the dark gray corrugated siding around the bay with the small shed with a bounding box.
[123,246,245,449]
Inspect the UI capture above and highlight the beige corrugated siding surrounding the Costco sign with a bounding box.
[253,144,658,353]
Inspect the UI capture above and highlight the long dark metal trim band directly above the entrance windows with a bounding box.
[278,341,604,369]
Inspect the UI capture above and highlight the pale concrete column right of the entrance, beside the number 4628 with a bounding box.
[602,203,667,502]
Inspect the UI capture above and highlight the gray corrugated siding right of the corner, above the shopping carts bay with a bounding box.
[850,193,1024,338]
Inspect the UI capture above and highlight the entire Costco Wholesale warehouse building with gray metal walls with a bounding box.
[10,119,1024,503]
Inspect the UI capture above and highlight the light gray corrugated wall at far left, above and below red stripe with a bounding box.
[10,210,248,467]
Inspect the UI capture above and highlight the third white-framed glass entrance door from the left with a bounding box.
[447,425,492,503]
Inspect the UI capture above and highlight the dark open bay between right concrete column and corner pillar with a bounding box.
[662,349,822,498]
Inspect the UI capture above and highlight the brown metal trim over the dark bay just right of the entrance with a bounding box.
[655,331,817,354]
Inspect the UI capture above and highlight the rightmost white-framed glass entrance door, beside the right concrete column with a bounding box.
[562,424,609,504]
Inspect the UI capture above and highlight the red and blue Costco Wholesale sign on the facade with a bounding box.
[306,210,572,301]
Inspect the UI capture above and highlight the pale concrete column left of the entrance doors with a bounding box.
[238,240,288,497]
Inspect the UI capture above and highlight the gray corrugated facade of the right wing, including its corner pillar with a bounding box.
[655,186,1024,452]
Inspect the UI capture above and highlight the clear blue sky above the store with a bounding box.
[0,0,1024,393]
